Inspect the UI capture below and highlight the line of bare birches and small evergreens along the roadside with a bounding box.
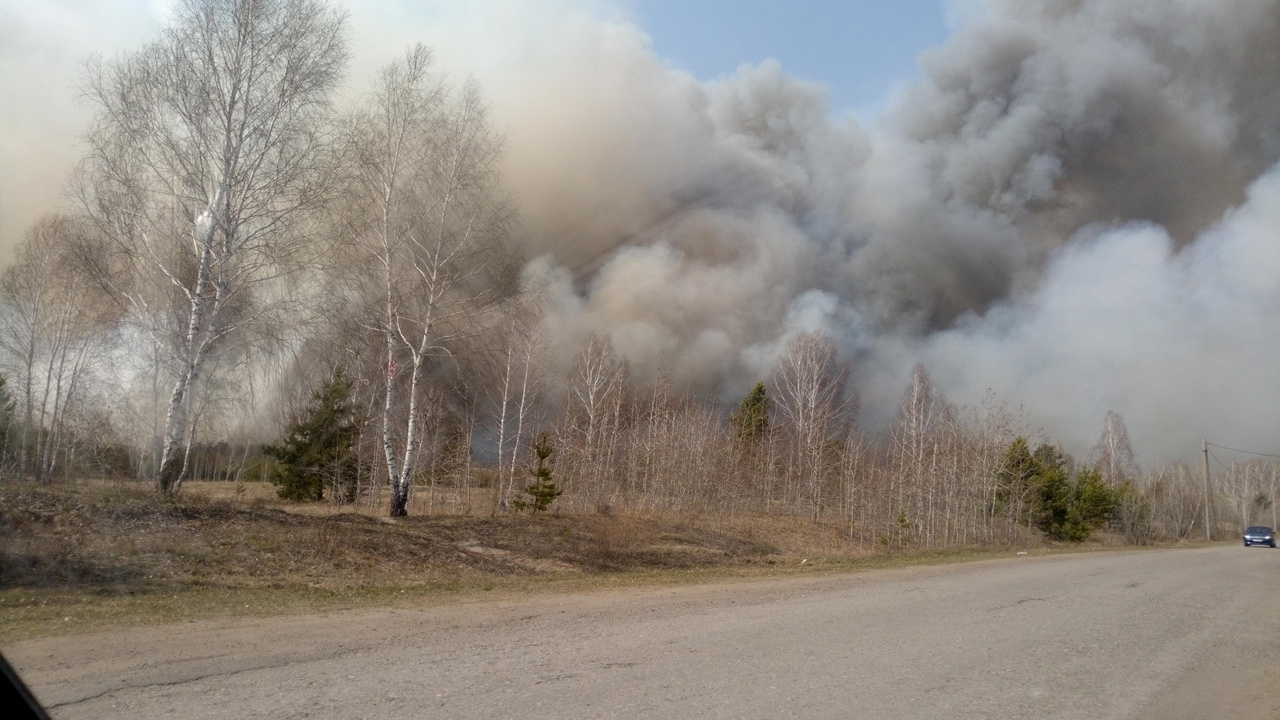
[0,0,1280,548]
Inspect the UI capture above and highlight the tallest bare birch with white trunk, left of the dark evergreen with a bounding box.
[78,0,347,493]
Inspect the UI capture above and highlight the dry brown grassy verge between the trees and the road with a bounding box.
[0,483,1177,641]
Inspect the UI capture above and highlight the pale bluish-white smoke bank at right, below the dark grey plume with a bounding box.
[916,167,1280,459]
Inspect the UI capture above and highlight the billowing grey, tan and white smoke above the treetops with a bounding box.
[0,0,1280,462]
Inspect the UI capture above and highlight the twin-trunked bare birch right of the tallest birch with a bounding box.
[344,45,521,516]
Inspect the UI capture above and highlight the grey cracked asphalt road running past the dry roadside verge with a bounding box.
[5,546,1280,720]
